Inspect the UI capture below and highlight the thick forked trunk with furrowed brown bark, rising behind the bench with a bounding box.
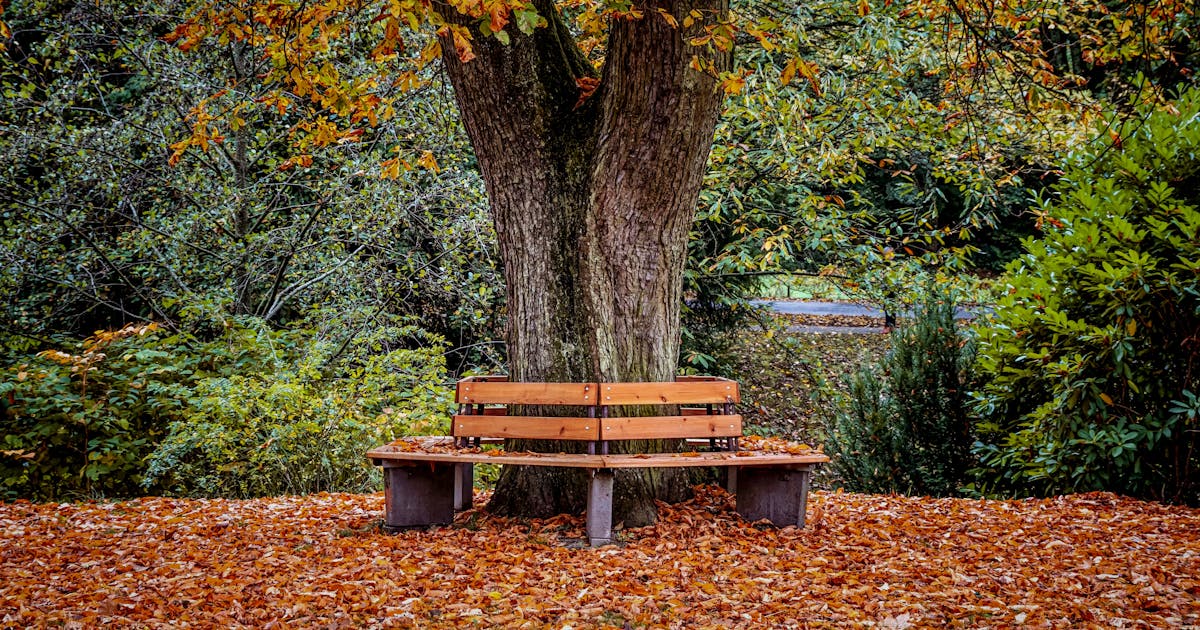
[443,0,730,526]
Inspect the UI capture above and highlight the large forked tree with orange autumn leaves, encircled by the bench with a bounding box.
[145,0,1182,523]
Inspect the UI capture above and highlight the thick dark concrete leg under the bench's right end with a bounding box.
[737,466,810,527]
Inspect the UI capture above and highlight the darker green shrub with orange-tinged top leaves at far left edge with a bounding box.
[0,324,200,499]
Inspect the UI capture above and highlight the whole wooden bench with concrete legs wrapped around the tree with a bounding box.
[367,377,829,545]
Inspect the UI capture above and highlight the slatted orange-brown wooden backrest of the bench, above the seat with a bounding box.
[451,376,742,442]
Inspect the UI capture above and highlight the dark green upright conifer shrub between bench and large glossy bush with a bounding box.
[827,288,974,497]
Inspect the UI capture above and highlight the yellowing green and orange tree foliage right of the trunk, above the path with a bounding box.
[692,0,1196,316]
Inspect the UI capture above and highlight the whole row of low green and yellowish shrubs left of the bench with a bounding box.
[0,319,449,499]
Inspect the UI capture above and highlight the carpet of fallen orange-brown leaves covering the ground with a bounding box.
[0,487,1200,628]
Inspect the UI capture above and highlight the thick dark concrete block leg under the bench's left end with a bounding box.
[383,463,456,529]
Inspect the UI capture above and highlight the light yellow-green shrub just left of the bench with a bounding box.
[145,326,452,497]
